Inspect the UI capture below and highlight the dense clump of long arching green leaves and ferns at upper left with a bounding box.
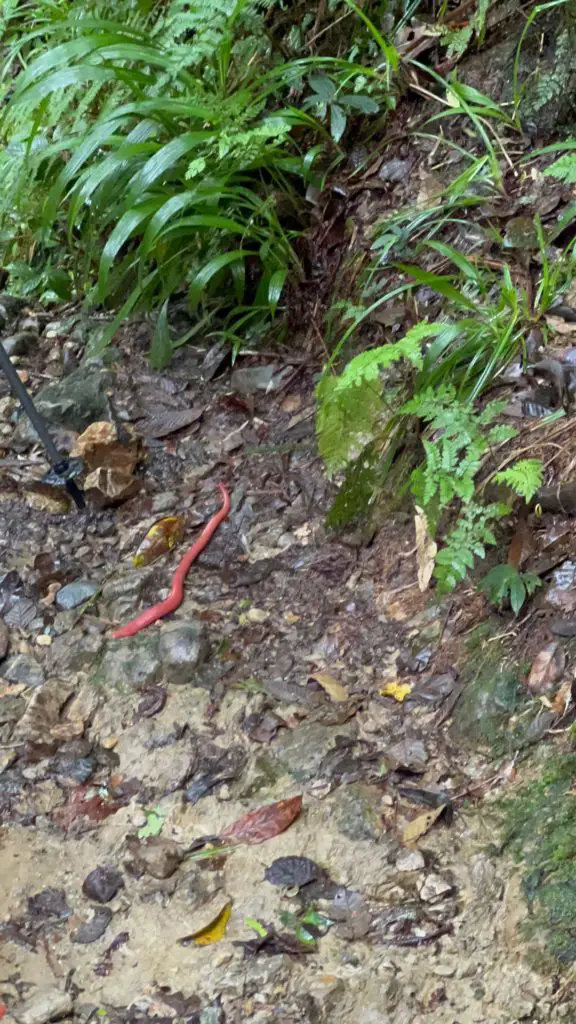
[0,0,387,348]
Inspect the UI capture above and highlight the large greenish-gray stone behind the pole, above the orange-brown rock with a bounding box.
[17,361,111,440]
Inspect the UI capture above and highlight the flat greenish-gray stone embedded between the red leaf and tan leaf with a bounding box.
[271,722,358,782]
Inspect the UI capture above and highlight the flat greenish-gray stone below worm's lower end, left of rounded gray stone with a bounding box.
[92,632,162,691]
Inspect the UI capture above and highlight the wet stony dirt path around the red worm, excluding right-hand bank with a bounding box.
[0,314,576,1024]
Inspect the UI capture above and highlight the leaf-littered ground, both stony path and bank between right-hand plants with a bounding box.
[0,8,576,1024]
